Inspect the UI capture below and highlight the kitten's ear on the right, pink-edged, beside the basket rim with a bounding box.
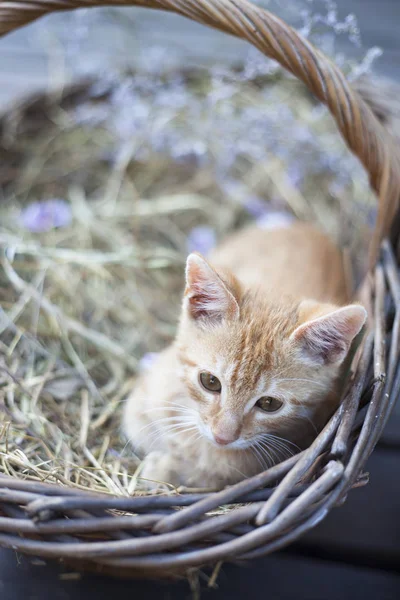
[291,304,367,365]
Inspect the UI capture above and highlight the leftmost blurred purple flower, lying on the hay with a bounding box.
[20,198,72,233]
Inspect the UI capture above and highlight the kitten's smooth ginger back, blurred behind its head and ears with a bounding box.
[210,222,350,305]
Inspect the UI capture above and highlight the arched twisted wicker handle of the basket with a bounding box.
[0,0,400,267]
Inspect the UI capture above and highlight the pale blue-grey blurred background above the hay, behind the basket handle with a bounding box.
[0,0,400,107]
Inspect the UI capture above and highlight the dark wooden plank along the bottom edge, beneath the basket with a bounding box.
[0,552,400,600]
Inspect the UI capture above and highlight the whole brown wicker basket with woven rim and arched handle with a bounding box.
[0,0,400,576]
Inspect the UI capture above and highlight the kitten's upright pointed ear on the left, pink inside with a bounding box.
[184,253,239,323]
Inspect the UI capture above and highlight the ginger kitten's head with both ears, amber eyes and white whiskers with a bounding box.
[177,254,366,449]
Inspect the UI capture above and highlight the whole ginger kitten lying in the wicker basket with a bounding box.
[124,218,367,488]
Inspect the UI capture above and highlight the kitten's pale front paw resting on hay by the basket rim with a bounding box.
[140,452,180,491]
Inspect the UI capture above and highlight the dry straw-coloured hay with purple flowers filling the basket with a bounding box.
[0,49,373,494]
